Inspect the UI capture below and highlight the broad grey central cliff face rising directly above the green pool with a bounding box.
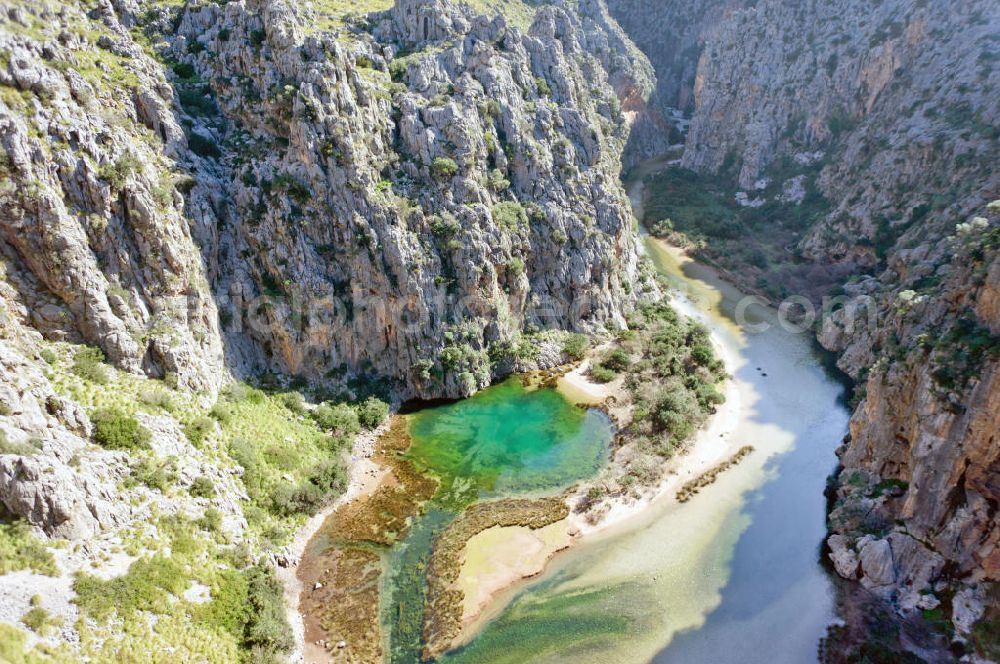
[173,0,637,397]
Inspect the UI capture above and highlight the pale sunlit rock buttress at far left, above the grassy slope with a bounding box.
[0,0,225,389]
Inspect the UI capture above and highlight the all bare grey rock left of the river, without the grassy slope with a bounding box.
[0,0,655,539]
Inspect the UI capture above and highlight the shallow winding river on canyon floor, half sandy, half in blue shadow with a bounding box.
[446,164,849,664]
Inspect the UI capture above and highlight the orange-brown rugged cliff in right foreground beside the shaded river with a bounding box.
[820,217,1000,634]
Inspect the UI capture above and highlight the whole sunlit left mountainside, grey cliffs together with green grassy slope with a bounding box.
[0,0,657,661]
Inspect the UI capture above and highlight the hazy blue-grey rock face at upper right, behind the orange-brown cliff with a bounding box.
[682,0,1000,266]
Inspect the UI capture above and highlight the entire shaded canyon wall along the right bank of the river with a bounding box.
[638,1,1000,655]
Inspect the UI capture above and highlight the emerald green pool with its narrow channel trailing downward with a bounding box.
[382,378,613,664]
